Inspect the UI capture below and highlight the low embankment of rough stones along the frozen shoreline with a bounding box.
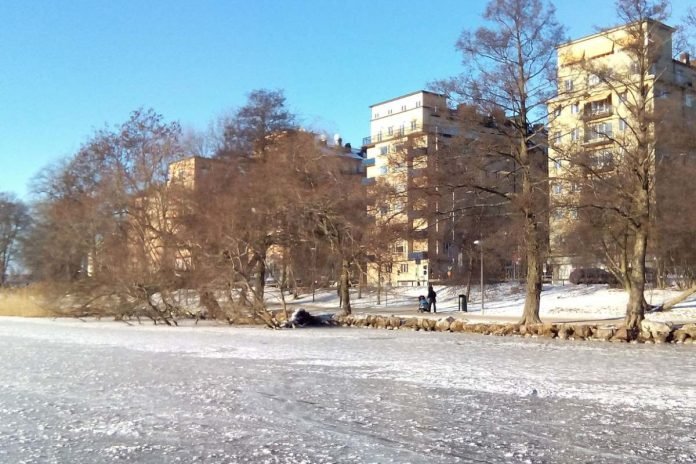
[334,315,696,344]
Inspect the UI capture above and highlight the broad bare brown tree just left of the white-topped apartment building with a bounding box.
[187,131,364,318]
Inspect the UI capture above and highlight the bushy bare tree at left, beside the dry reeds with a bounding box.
[30,110,186,323]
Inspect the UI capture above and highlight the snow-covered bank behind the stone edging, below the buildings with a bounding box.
[268,284,696,322]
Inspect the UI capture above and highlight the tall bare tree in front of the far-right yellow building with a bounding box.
[559,0,681,333]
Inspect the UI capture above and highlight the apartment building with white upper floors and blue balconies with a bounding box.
[363,90,457,286]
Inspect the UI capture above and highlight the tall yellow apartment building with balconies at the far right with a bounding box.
[548,20,696,279]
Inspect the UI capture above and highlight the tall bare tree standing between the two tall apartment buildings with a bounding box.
[436,0,563,324]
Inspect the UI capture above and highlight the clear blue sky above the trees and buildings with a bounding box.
[0,0,689,197]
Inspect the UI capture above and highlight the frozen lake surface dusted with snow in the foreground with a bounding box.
[0,318,696,463]
